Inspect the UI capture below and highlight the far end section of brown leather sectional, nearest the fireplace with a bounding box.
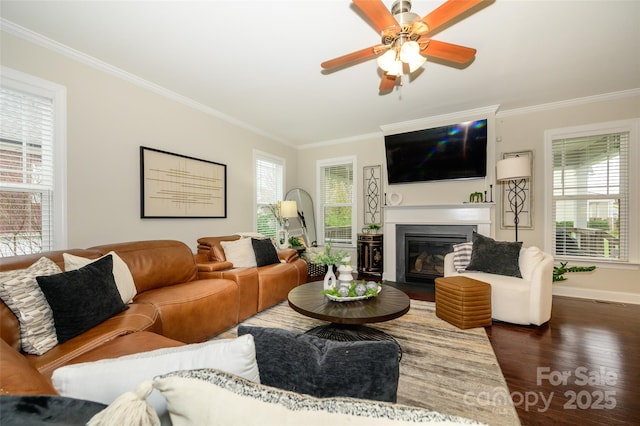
[196,235,307,321]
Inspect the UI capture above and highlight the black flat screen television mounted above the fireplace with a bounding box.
[384,119,487,184]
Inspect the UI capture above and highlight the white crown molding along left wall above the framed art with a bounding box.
[0,18,288,147]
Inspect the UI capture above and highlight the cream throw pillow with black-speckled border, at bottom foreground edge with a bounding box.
[139,369,480,426]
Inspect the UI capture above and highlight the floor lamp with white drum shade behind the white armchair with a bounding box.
[496,156,531,241]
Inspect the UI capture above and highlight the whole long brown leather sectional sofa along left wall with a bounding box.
[0,237,306,395]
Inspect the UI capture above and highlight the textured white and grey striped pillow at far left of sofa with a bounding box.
[0,257,62,355]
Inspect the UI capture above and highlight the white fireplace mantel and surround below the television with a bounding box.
[383,203,495,281]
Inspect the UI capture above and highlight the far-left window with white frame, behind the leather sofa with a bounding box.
[0,67,66,256]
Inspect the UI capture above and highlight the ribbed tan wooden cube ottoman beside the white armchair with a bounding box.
[435,276,491,329]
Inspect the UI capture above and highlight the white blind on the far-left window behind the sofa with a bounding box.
[0,87,54,256]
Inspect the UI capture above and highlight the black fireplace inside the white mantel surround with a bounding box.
[396,225,477,282]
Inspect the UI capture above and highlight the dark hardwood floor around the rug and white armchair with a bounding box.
[385,282,640,426]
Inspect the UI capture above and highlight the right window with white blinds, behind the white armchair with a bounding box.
[546,122,637,262]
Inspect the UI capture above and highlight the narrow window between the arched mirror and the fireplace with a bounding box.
[318,157,356,246]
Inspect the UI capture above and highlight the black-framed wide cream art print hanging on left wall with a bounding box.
[140,146,227,218]
